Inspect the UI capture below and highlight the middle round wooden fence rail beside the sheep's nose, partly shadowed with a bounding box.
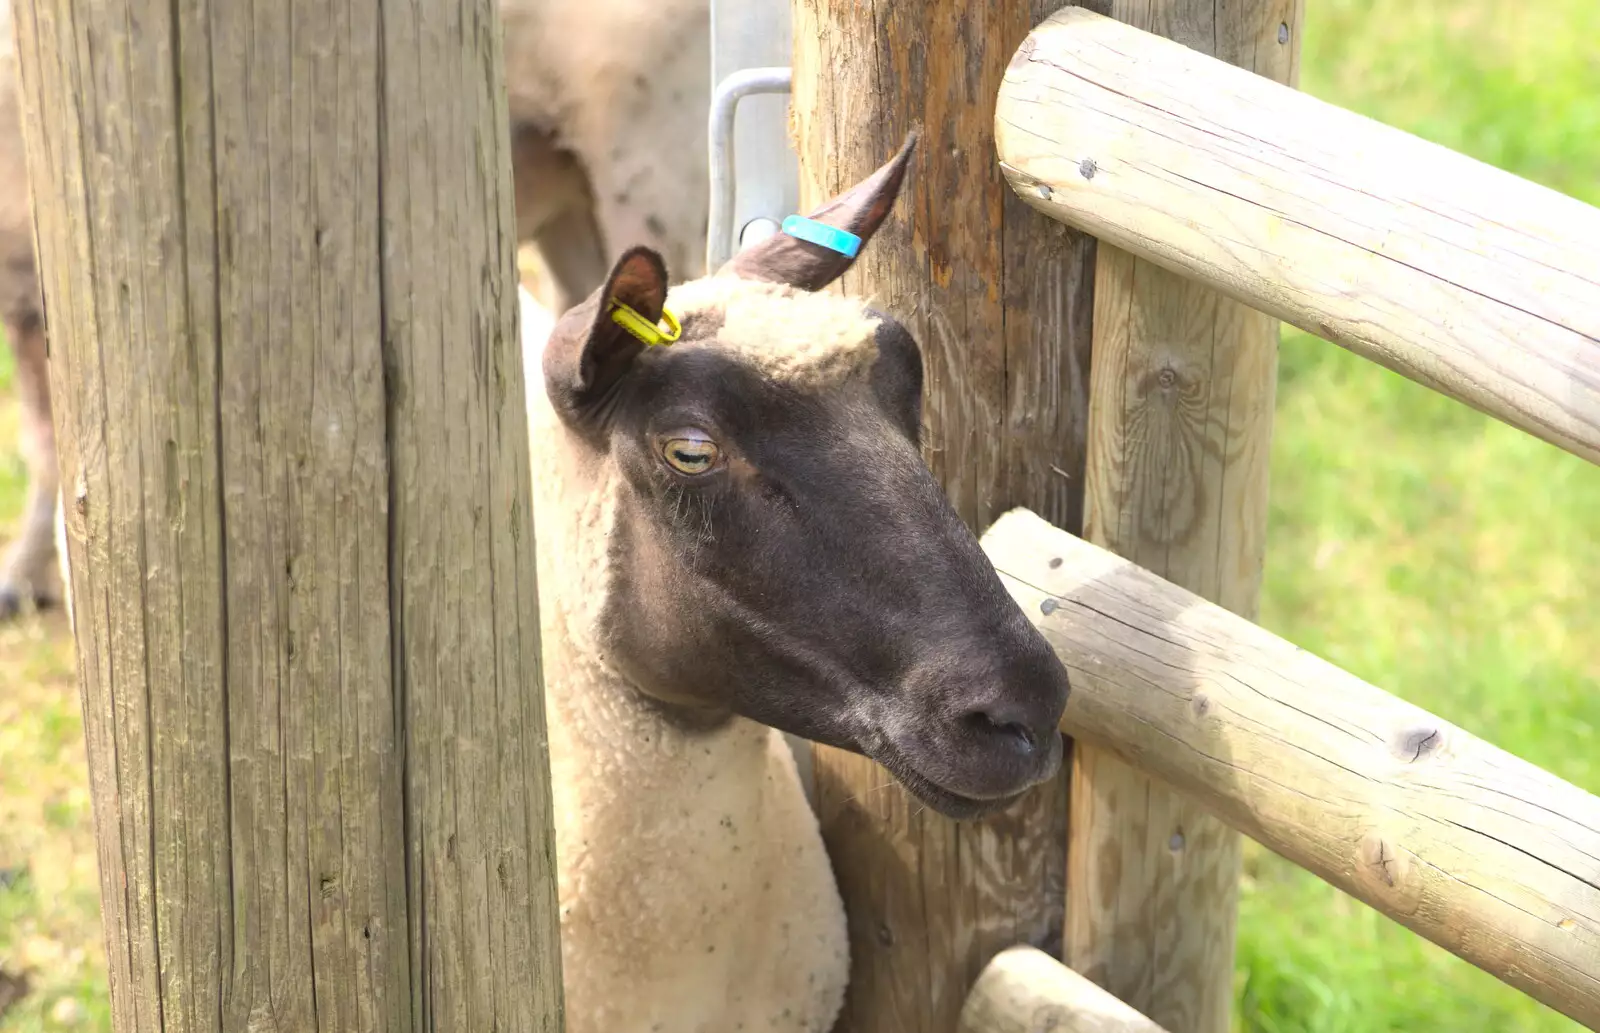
[984,512,1600,1028]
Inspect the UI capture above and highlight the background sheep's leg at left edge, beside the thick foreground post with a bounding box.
[0,313,61,619]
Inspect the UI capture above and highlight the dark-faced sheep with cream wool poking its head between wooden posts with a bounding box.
[523,142,1069,1033]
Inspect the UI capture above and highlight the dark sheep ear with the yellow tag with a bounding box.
[544,248,667,425]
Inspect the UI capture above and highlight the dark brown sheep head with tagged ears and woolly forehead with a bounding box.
[542,138,1069,817]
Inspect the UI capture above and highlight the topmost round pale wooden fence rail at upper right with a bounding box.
[997,5,1600,462]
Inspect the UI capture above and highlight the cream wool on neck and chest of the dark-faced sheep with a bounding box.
[522,288,848,1033]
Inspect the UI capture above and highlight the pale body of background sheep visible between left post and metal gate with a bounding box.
[499,0,710,315]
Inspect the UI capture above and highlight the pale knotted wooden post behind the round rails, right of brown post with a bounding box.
[1064,0,1304,1033]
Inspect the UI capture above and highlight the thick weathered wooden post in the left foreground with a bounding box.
[16,0,562,1033]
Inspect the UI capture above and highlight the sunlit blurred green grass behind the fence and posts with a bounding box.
[0,0,1600,1033]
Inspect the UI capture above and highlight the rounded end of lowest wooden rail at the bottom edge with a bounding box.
[960,947,1165,1033]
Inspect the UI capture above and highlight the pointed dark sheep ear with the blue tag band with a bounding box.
[718,131,917,291]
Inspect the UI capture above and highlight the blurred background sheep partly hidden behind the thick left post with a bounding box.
[0,0,710,620]
